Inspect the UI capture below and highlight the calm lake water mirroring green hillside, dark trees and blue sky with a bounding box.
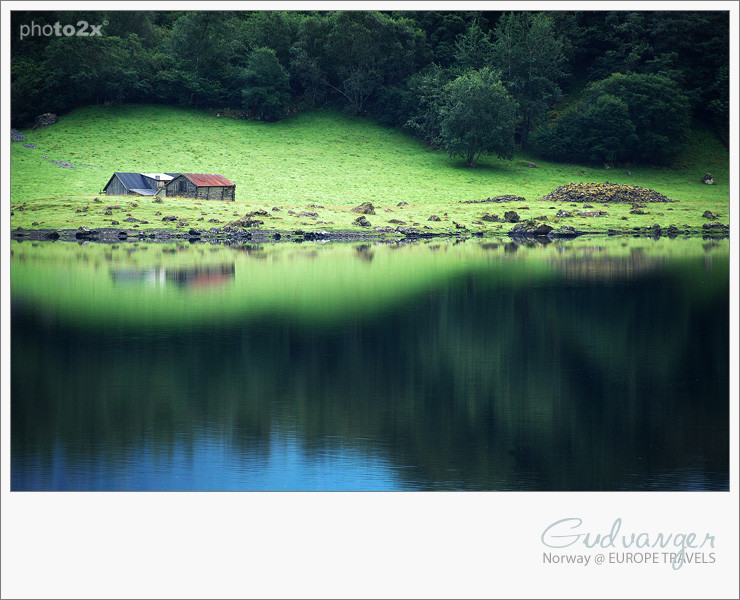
[11,237,729,491]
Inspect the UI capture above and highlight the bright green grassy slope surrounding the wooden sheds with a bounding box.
[11,105,729,233]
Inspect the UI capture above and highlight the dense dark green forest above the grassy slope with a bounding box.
[11,11,729,166]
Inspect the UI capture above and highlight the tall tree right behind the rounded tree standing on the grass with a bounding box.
[494,12,565,148]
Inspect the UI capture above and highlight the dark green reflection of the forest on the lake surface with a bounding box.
[12,264,729,489]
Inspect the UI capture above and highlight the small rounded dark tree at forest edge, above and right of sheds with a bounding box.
[242,48,290,121]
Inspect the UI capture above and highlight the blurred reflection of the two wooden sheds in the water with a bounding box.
[111,263,235,289]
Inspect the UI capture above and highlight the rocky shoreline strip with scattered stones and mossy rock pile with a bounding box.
[11,182,730,244]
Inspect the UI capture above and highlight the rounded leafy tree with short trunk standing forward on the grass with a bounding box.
[440,68,517,167]
